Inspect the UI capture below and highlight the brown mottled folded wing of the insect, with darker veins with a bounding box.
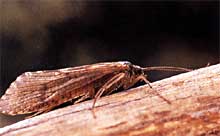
[0,62,128,115]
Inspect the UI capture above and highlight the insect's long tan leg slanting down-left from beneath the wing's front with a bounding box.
[92,73,125,109]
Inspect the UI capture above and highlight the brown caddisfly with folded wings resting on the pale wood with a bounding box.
[0,61,191,115]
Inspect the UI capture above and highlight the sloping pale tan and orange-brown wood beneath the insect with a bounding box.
[0,64,220,136]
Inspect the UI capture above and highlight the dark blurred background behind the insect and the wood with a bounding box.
[0,0,220,127]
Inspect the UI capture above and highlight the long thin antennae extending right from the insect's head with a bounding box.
[143,66,192,72]
